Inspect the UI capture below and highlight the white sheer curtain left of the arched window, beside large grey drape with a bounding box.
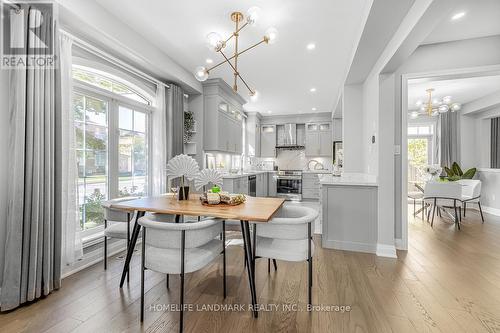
[59,34,83,266]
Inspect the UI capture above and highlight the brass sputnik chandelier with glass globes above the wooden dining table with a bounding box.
[194,7,278,100]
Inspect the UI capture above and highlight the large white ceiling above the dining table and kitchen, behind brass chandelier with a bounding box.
[96,0,371,115]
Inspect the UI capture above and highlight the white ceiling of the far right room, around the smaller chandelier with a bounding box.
[408,75,500,110]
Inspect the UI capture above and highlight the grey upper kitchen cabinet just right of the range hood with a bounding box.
[305,122,332,156]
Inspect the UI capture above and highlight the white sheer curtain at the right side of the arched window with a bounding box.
[152,84,168,195]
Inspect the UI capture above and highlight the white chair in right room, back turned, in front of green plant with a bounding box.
[424,181,462,230]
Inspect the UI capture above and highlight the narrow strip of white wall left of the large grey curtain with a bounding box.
[0,69,10,285]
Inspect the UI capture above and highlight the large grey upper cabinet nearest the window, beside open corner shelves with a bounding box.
[203,79,246,154]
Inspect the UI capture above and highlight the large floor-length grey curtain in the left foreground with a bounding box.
[0,5,64,311]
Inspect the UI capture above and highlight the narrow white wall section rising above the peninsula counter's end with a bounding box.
[342,84,366,172]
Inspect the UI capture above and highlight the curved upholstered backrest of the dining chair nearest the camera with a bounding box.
[139,214,222,249]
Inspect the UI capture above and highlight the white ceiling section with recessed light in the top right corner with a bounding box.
[423,0,500,44]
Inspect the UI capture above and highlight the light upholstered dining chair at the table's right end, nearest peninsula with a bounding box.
[254,206,319,304]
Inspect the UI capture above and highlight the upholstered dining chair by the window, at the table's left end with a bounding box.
[101,197,137,274]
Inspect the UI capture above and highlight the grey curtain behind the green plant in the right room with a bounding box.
[439,112,460,167]
